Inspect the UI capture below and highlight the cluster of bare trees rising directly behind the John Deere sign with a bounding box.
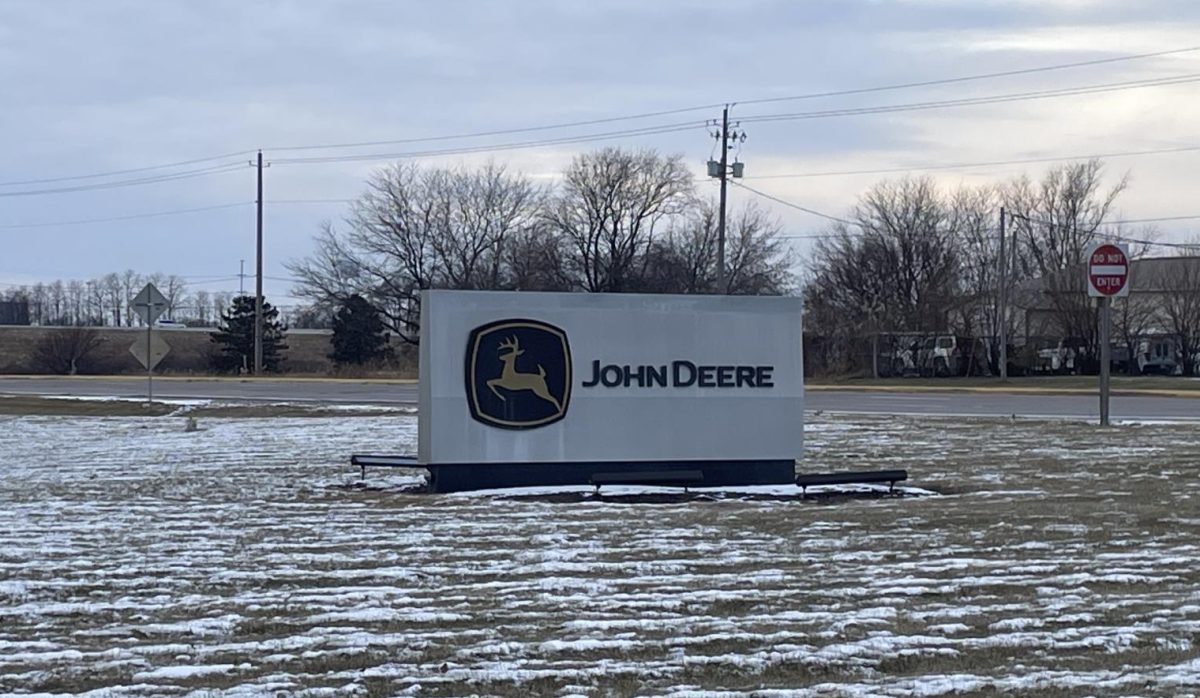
[288,148,793,343]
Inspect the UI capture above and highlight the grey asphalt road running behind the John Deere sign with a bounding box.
[0,378,1200,420]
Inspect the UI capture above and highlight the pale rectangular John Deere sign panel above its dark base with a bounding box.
[418,290,804,464]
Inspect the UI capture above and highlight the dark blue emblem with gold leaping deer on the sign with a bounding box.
[467,320,571,429]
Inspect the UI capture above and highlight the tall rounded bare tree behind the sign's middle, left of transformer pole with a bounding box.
[545,148,692,291]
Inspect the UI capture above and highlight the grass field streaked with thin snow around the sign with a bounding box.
[0,414,1200,696]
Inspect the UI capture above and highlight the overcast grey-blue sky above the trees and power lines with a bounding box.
[0,0,1200,305]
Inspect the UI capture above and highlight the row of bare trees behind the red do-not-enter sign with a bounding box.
[805,160,1200,374]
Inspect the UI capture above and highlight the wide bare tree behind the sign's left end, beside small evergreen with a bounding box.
[288,159,541,342]
